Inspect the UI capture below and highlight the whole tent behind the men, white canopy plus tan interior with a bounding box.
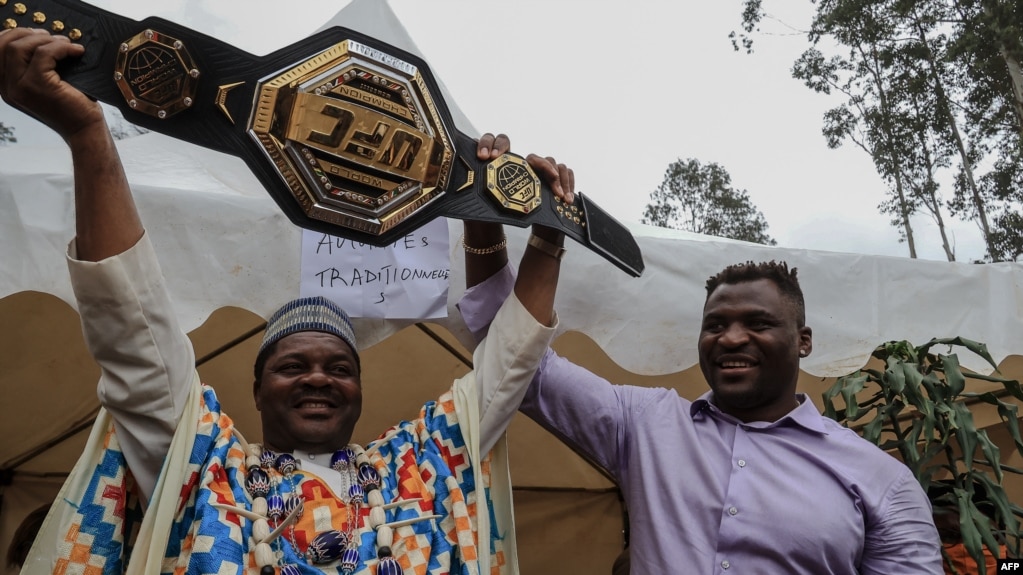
[0,0,1023,573]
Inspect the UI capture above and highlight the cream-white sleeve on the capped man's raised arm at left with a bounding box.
[68,234,195,498]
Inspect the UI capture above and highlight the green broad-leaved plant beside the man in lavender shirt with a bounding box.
[825,338,1023,565]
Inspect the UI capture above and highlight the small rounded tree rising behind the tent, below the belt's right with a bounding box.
[641,158,776,246]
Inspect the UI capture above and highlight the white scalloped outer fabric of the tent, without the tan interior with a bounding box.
[0,129,1023,377]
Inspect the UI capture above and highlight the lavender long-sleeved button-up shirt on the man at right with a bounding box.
[459,267,942,575]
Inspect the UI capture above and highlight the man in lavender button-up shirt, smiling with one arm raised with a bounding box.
[459,178,942,575]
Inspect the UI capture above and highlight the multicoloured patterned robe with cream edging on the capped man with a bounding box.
[23,374,516,575]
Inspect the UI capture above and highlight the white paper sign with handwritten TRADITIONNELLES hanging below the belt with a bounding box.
[300,218,451,319]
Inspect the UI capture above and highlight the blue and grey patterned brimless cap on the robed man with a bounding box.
[259,296,359,358]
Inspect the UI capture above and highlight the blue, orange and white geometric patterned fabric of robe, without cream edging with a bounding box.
[48,386,504,575]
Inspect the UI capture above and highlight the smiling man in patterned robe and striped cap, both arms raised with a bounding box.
[0,29,561,575]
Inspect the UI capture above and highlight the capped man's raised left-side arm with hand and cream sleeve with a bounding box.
[0,29,194,495]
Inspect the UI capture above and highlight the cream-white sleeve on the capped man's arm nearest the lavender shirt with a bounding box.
[473,292,558,453]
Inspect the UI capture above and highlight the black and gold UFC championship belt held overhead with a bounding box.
[0,0,643,276]
